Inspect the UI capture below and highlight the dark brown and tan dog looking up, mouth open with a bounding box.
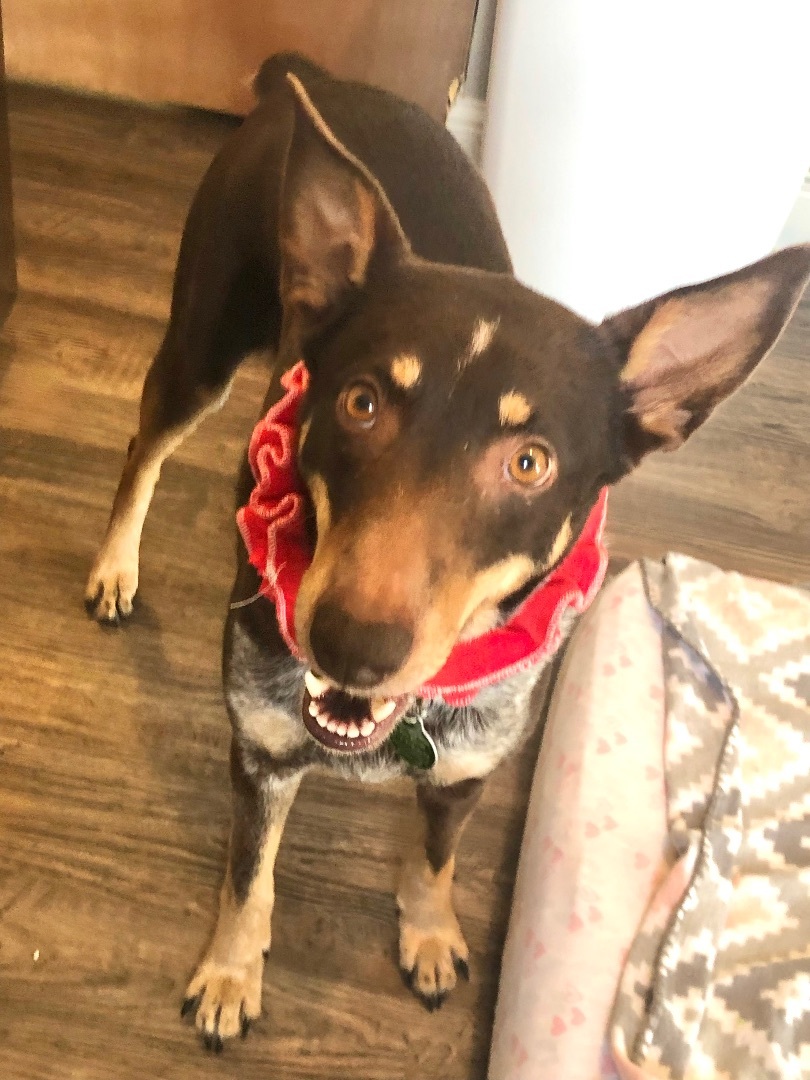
[87,56,810,1050]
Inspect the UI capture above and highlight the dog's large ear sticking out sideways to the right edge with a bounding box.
[599,245,810,469]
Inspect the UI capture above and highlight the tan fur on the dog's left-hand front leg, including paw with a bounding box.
[184,774,301,1050]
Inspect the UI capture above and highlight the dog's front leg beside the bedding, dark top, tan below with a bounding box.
[396,779,484,1012]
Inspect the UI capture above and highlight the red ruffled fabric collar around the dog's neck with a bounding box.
[237,362,607,705]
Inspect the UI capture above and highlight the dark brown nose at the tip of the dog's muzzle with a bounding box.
[309,600,414,687]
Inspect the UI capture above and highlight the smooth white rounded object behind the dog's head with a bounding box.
[483,0,810,319]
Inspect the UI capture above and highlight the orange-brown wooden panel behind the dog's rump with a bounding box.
[4,0,475,118]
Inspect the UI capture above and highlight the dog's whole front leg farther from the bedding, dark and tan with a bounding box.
[183,740,302,1052]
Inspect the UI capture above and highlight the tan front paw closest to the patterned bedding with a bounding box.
[400,915,470,1012]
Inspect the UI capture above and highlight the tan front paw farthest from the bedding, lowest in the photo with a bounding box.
[180,954,264,1054]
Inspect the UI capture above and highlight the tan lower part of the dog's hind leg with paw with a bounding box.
[84,382,231,622]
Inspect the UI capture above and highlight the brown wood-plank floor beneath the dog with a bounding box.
[0,89,810,1080]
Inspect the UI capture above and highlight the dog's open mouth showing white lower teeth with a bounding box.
[301,671,411,754]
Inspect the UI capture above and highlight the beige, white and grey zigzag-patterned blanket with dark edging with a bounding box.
[610,555,810,1080]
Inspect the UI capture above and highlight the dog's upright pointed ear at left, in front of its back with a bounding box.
[280,75,408,336]
